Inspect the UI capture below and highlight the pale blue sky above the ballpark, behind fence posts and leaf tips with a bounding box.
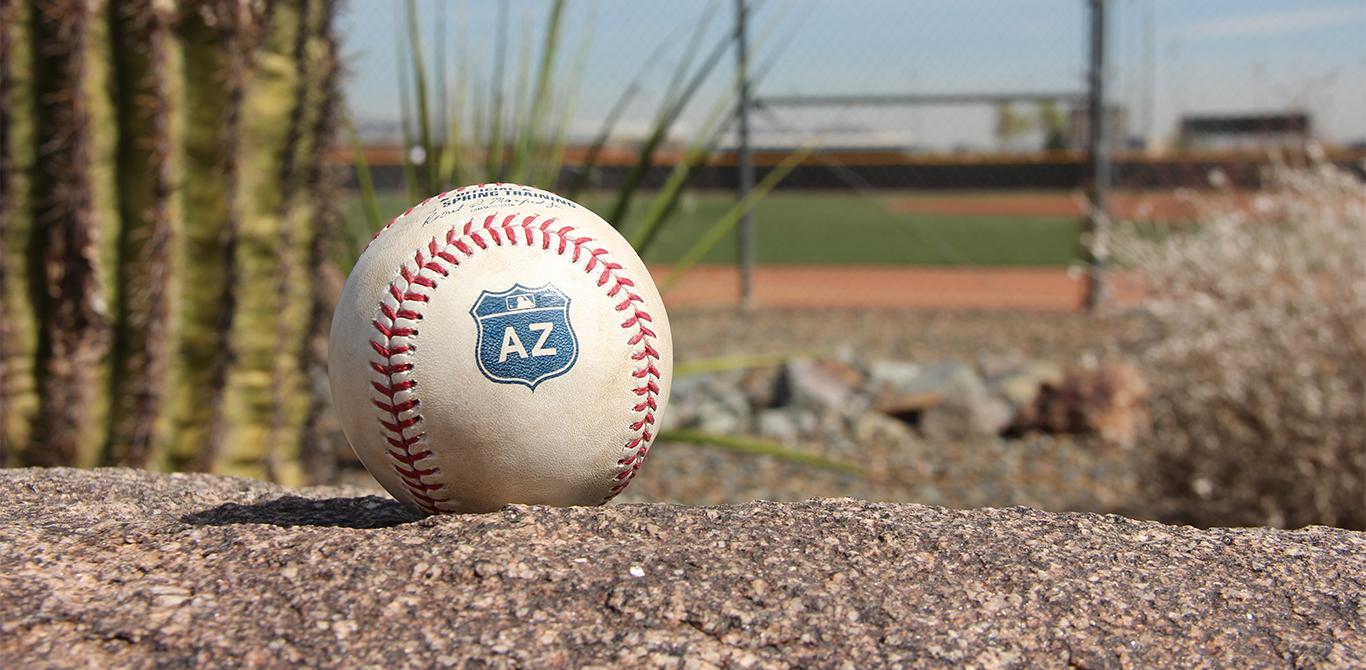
[342,0,1366,149]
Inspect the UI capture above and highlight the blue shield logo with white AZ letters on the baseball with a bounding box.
[470,284,579,391]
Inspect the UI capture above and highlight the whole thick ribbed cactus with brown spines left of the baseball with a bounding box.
[0,0,339,481]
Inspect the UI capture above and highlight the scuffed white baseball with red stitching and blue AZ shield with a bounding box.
[328,183,673,514]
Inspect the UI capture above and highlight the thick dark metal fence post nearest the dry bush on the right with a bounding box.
[1085,0,1111,310]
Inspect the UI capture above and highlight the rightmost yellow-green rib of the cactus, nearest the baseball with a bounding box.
[229,3,309,477]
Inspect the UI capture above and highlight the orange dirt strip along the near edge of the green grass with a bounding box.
[650,265,1141,312]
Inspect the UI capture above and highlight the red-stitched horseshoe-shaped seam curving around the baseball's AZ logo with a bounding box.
[370,198,661,514]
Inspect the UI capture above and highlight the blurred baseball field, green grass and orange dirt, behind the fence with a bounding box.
[348,191,1174,312]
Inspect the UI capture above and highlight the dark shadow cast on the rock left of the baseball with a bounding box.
[180,495,422,528]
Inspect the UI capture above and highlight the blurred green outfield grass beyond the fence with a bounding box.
[347,191,1079,267]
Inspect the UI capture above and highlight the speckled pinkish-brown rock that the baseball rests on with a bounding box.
[0,469,1366,669]
